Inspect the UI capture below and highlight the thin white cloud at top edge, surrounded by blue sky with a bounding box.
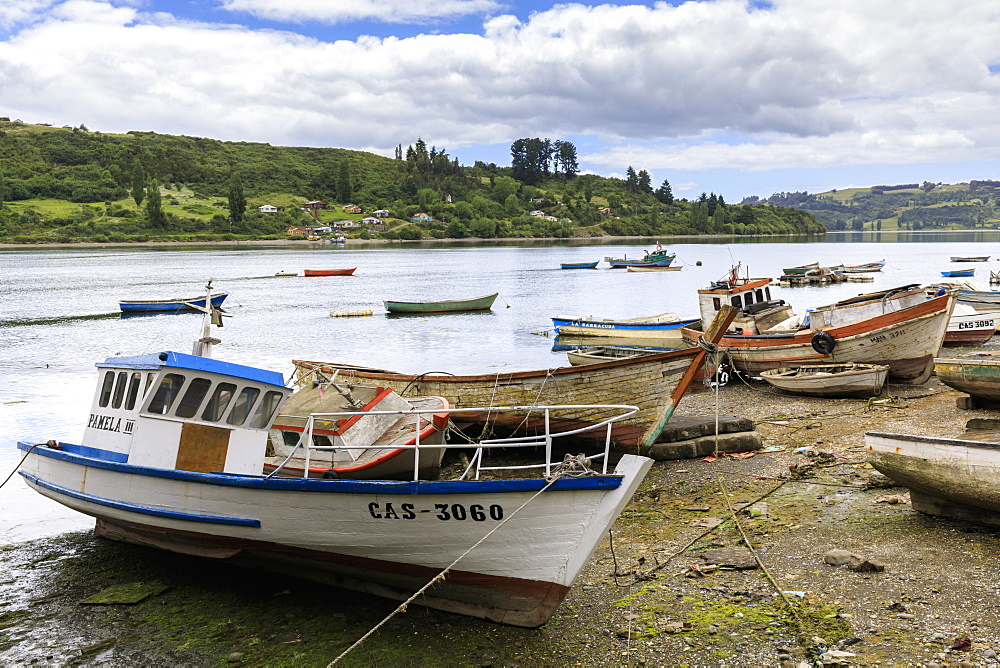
[221,0,498,23]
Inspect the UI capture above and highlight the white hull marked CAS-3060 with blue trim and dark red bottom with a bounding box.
[18,443,652,627]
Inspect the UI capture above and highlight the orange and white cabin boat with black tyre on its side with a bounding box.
[682,268,954,384]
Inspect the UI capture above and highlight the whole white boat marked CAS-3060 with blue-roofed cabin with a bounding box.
[18,296,652,627]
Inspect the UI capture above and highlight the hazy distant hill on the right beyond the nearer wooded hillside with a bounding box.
[741,180,1000,230]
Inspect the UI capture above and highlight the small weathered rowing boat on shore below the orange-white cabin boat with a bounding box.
[760,363,889,397]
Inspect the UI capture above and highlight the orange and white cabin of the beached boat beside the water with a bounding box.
[698,276,793,334]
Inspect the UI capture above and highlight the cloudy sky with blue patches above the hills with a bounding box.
[0,0,1000,202]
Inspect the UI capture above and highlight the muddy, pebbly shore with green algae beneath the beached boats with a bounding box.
[0,381,1000,667]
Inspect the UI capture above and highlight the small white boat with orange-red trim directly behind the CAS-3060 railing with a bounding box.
[264,382,448,480]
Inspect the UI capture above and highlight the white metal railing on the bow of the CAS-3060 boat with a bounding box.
[266,404,639,480]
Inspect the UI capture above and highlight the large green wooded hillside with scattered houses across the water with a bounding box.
[0,117,825,243]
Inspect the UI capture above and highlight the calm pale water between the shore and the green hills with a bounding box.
[0,232,1000,539]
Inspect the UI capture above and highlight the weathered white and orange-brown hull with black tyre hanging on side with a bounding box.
[684,295,954,384]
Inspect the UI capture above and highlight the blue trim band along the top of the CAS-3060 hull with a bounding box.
[17,441,622,494]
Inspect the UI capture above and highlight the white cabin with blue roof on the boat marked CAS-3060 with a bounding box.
[83,352,291,475]
